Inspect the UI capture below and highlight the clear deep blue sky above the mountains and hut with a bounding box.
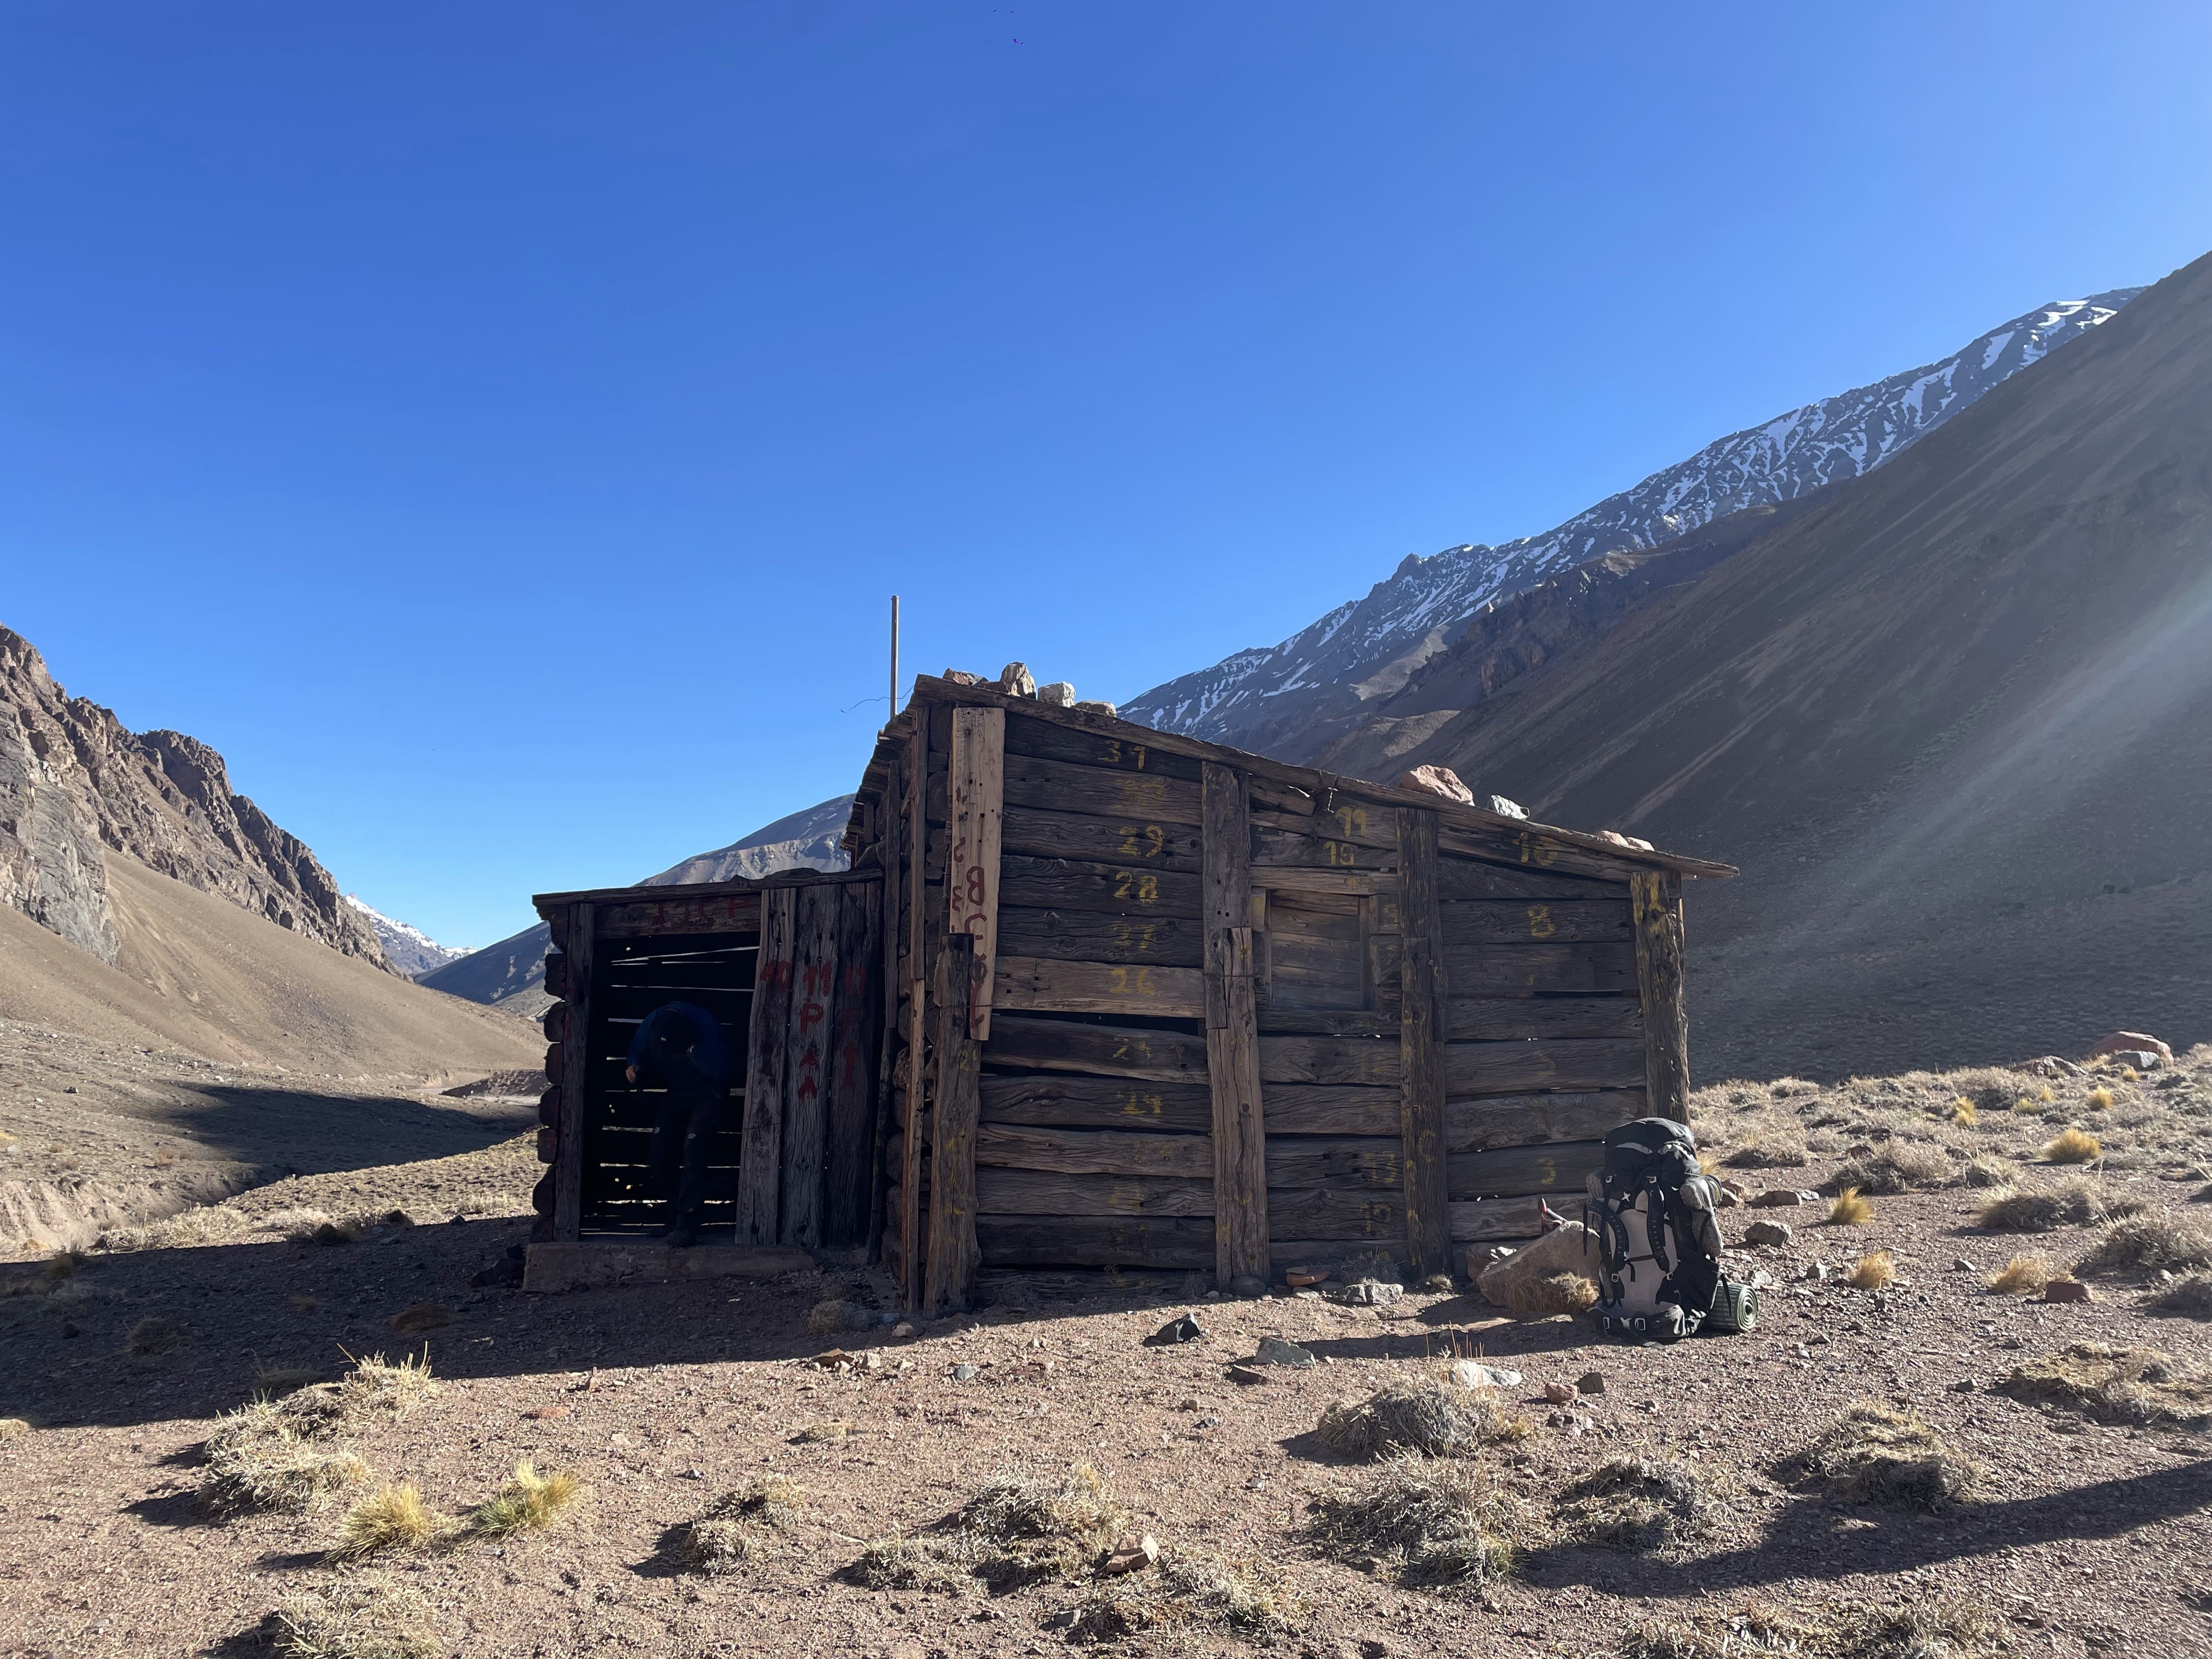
[0,0,2212,945]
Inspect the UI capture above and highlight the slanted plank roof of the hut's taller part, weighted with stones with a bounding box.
[843,675,1736,881]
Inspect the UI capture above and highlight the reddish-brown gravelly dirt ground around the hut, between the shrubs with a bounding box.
[0,1051,2212,1659]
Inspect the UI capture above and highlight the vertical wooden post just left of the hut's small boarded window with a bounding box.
[1199,761,1269,1288]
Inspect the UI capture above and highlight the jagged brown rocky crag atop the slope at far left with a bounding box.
[0,628,390,967]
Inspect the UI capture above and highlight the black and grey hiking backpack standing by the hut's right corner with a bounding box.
[1588,1117,1758,1342]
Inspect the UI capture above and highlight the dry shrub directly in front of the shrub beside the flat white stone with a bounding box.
[1307,1453,1531,1588]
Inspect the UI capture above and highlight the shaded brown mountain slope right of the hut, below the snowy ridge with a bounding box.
[1329,246,2212,1080]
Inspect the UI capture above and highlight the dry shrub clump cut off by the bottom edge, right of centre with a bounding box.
[1612,1597,2008,1659]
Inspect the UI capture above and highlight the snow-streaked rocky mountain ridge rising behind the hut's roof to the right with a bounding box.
[1121,287,2143,759]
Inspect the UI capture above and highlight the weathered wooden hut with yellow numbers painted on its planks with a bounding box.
[517,677,1734,1312]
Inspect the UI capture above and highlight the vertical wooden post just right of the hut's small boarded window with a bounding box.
[1398,808,1451,1278]
